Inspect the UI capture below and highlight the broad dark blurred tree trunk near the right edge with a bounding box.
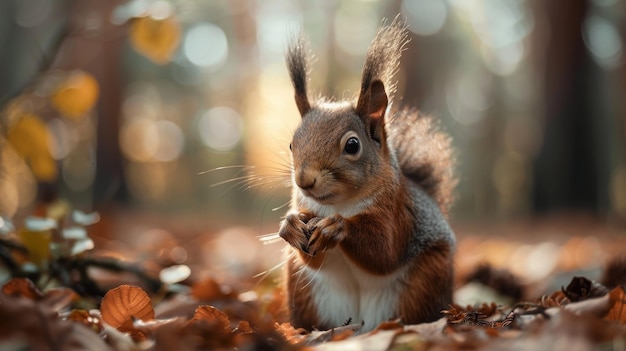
[533,0,623,213]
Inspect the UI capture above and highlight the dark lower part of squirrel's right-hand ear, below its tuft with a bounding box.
[356,79,389,142]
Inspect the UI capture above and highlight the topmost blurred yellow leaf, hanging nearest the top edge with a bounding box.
[130,16,181,64]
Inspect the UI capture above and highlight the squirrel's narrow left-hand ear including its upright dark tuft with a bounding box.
[286,35,311,117]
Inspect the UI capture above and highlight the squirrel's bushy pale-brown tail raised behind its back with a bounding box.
[387,110,457,215]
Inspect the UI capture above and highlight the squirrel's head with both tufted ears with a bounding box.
[287,19,407,204]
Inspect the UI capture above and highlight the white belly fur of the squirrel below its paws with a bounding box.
[306,248,404,331]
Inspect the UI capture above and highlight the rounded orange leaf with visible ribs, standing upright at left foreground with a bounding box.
[100,285,154,331]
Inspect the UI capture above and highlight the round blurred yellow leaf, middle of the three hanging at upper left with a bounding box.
[52,71,100,119]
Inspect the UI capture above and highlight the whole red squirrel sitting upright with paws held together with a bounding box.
[278,19,455,331]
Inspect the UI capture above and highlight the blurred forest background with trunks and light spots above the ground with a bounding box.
[0,0,626,264]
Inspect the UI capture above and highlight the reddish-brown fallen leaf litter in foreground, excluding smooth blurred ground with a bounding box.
[0,208,626,350]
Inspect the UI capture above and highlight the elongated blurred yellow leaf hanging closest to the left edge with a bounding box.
[7,113,57,182]
